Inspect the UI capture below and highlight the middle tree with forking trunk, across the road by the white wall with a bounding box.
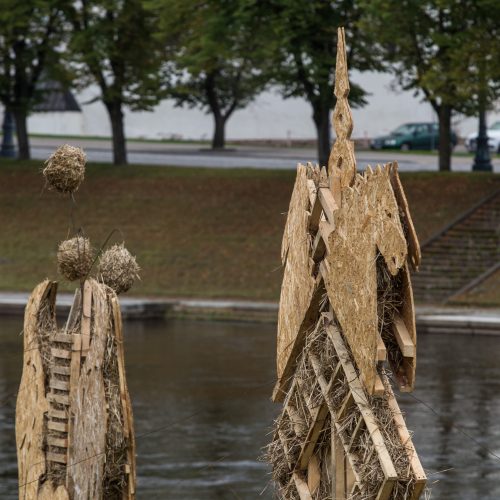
[152,0,267,149]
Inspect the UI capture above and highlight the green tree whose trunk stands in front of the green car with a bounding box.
[361,0,474,171]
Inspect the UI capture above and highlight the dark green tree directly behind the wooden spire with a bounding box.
[260,0,379,165]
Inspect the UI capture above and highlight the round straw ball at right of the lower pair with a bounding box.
[98,243,140,294]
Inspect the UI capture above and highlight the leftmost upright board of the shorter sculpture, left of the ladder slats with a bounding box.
[16,280,57,498]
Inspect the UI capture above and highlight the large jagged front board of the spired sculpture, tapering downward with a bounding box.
[324,165,407,394]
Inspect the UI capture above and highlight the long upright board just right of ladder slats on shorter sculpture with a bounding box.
[67,280,110,498]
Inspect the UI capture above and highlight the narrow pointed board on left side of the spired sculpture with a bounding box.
[276,164,315,378]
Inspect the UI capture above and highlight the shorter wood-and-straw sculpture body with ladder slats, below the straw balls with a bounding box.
[16,279,135,500]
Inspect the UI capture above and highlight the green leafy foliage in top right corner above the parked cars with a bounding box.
[361,0,500,112]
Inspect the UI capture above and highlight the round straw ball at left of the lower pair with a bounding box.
[57,236,94,281]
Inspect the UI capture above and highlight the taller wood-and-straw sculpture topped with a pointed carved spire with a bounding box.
[267,29,426,500]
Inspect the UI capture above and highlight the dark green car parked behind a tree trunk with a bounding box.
[370,122,457,151]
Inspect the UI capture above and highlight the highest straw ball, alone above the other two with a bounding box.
[43,144,87,193]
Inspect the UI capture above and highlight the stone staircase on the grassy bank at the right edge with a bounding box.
[412,190,500,304]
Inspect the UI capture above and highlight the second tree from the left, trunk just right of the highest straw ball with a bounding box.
[70,0,163,165]
